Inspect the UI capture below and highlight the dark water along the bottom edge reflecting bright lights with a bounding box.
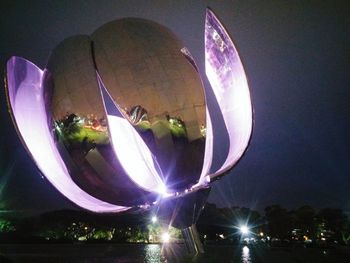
[0,244,350,263]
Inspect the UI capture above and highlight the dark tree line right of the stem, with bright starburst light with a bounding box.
[197,203,350,245]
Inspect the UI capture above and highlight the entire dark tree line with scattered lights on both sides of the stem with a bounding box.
[0,203,350,245]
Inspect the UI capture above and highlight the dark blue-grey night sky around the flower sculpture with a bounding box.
[0,0,350,212]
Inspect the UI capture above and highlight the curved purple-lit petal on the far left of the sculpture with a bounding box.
[7,57,129,212]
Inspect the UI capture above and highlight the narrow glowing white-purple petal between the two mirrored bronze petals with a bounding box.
[96,72,165,194]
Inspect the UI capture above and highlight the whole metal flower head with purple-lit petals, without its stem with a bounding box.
[6,10,253,224]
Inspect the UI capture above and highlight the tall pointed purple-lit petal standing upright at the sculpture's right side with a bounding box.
[205,10,253,176]
